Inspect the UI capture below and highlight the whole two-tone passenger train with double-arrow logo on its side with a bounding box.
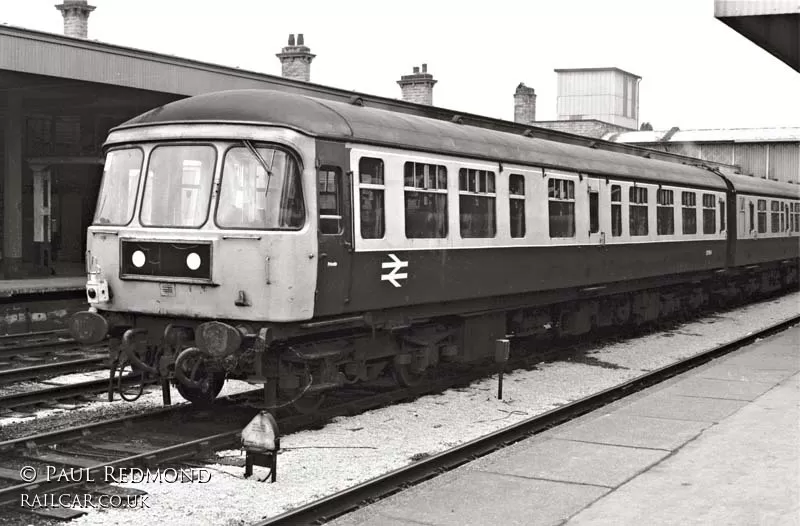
[71,90,800,410]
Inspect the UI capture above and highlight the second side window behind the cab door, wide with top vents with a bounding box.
[404,161,447,239]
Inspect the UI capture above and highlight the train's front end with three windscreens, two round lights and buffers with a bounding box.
[70,124,317,408]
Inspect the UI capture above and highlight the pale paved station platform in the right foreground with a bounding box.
[330,327,800,526]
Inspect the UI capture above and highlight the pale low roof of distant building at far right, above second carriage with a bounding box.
[603,127,800,144]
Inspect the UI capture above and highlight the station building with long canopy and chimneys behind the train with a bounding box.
[0,0,780,284]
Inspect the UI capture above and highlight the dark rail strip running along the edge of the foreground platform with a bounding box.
[253,316,800,526]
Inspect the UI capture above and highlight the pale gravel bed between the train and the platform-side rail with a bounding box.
[4,293,800,526]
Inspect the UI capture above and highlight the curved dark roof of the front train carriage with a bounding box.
[112,89,788,195]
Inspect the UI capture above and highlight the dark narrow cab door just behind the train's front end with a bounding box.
[315,141,353,315]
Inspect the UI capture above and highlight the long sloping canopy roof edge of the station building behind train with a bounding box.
[0,25,736,171]
